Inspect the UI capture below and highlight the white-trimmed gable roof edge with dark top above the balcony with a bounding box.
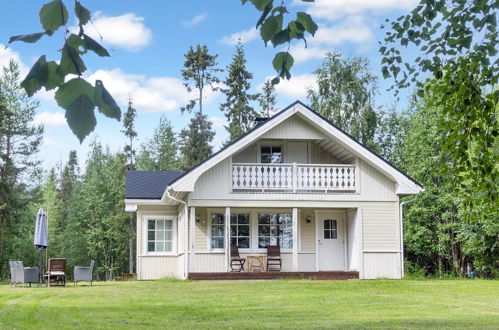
[167,101,423,199]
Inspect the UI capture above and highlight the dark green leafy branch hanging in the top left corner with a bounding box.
[9,0,121,143]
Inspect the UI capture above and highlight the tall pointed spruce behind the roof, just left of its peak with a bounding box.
[220,42,256,141]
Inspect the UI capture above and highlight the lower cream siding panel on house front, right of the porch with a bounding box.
[362,252,401,279]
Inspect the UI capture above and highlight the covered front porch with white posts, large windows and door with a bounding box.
[187,207,360,279]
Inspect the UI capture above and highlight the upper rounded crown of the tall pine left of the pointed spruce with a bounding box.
[180,44,222,114]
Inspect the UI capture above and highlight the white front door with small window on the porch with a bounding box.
[316,211,346,271]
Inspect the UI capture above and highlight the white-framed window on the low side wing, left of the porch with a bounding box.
[147,219,174,253]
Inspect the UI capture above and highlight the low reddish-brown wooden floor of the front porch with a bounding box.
[189,271,359,281]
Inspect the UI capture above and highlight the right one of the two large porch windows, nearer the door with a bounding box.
[258,213,293,249]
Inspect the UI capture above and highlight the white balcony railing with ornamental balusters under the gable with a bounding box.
[232,163,357,193]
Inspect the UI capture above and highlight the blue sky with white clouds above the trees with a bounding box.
[0,0,417,169]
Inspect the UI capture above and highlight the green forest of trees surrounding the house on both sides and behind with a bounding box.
[0,1,499,280]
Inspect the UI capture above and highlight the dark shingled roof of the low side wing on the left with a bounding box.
[125,171,184,199]
